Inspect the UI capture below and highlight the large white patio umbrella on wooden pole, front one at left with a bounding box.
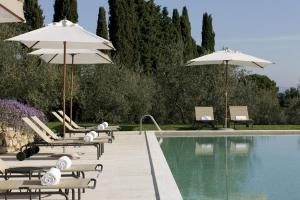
[8,20,114,136]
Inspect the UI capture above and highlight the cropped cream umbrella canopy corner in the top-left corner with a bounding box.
[0,0,25,23]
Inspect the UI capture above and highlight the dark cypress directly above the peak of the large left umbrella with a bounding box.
[53,0,78,23]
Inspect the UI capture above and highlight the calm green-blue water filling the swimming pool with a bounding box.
[161,136,300,200]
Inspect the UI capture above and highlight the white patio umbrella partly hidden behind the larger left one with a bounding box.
[29,49,113,123]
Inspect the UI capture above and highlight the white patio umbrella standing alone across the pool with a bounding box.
[186,49,272,128]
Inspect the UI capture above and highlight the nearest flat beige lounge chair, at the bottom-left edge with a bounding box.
[0,178,96,200]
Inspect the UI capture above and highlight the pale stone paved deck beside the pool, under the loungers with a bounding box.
[0,132,183,200]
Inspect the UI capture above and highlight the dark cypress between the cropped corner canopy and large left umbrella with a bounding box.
[24,0,44,30]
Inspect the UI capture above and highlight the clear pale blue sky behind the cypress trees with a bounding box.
[39,0,300,90]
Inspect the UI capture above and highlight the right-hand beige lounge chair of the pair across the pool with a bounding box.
[229,106,253,128]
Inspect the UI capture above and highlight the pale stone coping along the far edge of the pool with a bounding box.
[155,130,300,137]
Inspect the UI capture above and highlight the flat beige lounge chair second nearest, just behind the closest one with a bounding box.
[0,159,103,180]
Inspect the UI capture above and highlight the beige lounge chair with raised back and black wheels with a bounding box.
[17,117,109,161]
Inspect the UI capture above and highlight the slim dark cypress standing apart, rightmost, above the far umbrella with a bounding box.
[198,13,215,55]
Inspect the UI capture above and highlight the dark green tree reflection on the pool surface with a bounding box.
[161,137,288,200]
